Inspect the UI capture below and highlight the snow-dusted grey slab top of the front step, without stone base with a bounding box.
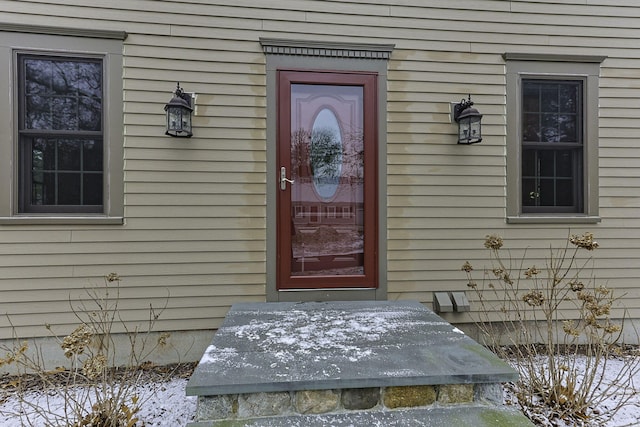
[186,301,517,396]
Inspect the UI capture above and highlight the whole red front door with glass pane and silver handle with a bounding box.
[275,71,378,289]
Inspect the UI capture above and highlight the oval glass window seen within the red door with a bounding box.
[309,108,343,200]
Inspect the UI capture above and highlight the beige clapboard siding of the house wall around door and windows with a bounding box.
[0,0,640,339]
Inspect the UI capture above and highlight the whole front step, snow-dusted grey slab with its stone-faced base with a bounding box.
[187,301,530,426]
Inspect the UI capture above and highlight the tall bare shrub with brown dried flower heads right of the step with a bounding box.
[462,233,639,425]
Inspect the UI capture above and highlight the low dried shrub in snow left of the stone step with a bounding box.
[0,273,180,427]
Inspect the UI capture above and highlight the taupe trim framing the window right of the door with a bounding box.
[504,53,605,224]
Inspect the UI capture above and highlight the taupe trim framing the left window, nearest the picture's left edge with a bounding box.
[0,22,127,225]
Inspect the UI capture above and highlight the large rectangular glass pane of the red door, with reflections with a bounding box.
[291,84,365,276]
